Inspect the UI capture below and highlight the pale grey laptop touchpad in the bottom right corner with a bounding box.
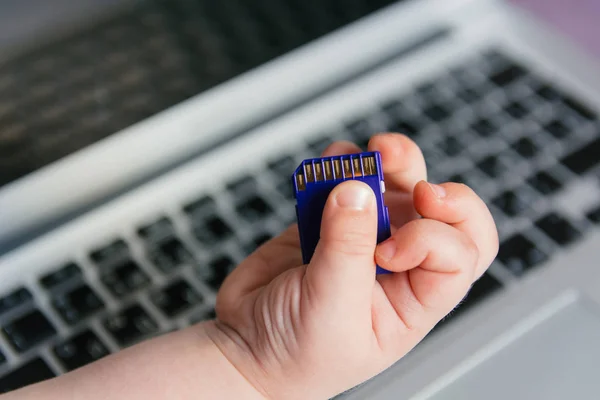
[429,299,600,400]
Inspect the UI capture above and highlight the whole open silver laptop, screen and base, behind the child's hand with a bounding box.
[0,0,600,399]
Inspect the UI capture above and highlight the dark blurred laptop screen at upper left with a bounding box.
[0,0,404,187]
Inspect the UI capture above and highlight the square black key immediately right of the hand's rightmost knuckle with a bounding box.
[498,234,548,276]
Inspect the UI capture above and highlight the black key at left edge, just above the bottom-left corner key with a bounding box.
[2,310,56,353]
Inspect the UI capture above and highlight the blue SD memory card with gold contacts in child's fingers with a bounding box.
[292,152,390,274]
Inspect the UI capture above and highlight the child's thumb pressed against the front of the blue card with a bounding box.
[305,181,377,312]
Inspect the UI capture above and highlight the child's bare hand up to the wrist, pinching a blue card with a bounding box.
[211,134,498,399]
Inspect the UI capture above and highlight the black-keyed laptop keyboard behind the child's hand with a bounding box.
[0,52,600,392]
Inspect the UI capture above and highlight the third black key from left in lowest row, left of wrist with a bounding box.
[104,305,159,347]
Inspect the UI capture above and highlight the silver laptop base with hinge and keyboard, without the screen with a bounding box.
[0,0,600,399]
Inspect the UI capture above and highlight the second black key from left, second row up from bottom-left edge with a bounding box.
[52,285,104,325]
